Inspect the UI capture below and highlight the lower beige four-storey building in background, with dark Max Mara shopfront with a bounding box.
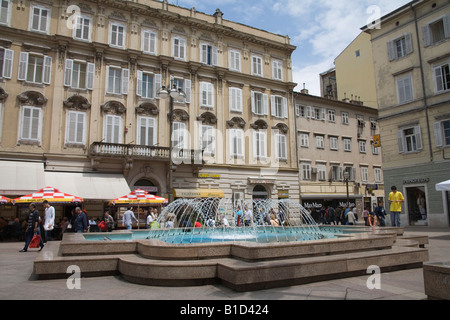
[295,93,384,216]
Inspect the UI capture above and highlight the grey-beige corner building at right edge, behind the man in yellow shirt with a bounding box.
[362,0,450,226]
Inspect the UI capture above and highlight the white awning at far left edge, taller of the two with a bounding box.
[0,161,45,196]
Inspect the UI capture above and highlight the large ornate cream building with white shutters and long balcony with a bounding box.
[0,0,299,220]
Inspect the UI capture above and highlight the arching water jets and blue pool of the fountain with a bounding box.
[147,198,331,244]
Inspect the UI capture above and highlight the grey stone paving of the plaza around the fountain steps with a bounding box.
[0,227,450,301]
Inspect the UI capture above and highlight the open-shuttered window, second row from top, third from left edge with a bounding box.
[64,59,95,90]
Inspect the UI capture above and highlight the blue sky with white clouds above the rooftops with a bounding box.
[169,0,410,96]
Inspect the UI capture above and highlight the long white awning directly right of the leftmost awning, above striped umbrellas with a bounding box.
[45,172,131,201]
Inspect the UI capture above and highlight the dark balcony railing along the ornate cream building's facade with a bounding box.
[89,142,203,164]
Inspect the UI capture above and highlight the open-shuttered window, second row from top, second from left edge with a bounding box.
[17,52,52,84]
